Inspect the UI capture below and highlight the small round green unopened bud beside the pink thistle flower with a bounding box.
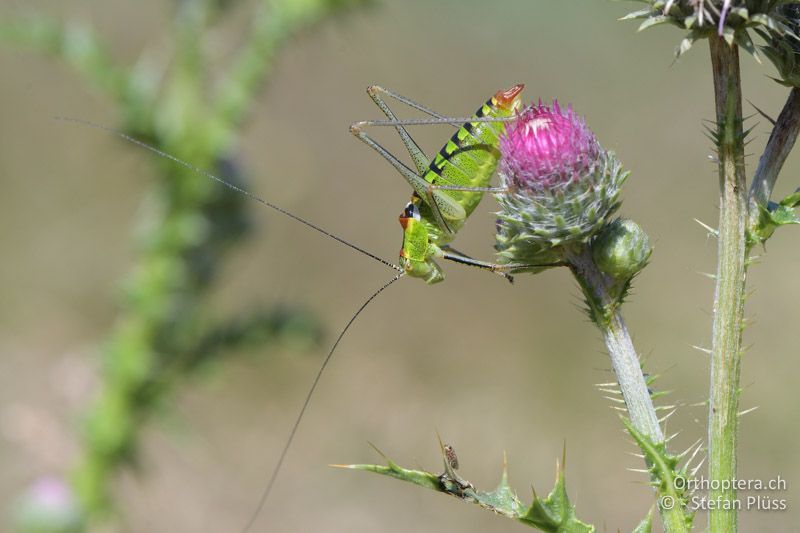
[592,218,653,281]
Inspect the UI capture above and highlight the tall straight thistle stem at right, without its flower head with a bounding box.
[708,36,747,533]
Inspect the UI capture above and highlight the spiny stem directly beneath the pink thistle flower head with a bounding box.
[567,247,689,533]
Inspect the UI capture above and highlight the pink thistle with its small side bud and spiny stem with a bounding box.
[497,103,692,532]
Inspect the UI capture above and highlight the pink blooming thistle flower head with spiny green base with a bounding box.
[495,102,628,264]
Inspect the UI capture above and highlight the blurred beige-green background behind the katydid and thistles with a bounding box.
[0,0,800,533]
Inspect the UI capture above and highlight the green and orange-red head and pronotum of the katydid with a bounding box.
[399,197,444,285]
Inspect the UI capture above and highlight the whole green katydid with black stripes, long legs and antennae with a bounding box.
[59,85,556,531]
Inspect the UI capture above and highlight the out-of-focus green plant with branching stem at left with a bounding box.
[0,0,364,531]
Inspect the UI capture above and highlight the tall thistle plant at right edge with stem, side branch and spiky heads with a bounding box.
[626,0,800,533]
